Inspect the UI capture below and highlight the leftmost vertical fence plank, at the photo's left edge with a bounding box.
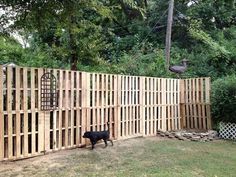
[0,65,4,161]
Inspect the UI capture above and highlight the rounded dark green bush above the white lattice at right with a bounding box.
[212,75,236,123]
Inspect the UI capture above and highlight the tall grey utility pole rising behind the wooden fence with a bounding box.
[165,0,174,71]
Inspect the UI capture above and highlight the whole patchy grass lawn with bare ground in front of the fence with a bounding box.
[0,137,236,177]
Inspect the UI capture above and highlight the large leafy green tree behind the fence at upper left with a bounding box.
[1,0,112,70]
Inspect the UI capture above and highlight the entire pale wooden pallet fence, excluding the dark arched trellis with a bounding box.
[0,66,211,161]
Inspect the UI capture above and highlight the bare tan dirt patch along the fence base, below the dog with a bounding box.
[0,137,163,177]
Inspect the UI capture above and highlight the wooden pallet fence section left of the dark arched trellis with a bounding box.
[0,66,40,160]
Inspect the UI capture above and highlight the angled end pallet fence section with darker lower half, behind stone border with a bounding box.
[180,78,212,129]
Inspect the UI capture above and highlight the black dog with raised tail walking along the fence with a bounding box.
[83,122,113,149]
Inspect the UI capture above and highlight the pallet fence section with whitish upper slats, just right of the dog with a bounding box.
[118,75,142,139]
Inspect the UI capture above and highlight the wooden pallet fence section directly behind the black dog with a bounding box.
[86,73,117,138]
